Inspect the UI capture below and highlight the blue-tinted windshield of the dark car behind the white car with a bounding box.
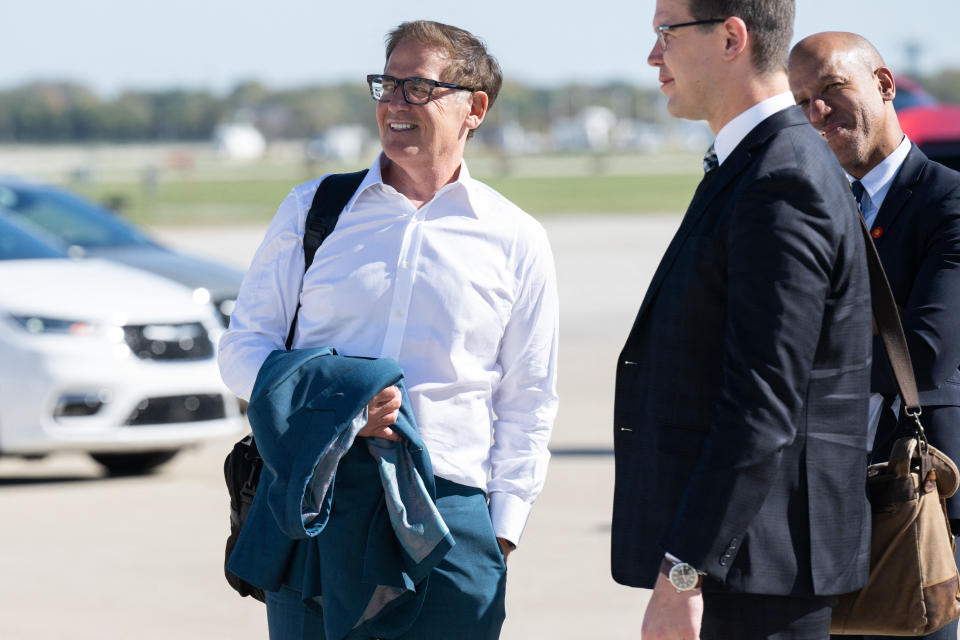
[0,184,153,248]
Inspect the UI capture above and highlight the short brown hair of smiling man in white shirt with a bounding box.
[386,20,503,109]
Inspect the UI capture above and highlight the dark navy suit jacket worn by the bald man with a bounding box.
[870,146,960,518]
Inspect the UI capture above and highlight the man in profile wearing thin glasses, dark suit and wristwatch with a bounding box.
[612,0,871,640]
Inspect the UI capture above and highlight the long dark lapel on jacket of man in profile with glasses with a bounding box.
[634,107,809,328]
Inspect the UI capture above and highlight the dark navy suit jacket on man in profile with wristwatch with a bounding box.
[612,107,871,595]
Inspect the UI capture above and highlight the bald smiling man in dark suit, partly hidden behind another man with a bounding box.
[789,32,960,640]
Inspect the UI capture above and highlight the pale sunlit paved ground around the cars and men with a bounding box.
[0,214,680,640]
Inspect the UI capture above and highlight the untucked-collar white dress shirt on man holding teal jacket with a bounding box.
[219,155,558,543]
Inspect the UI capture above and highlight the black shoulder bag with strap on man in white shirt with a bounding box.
[223,169,367,602]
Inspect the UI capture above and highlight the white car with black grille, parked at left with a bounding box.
[0,216,245,474]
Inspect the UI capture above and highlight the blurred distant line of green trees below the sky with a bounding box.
[0,69,960,143]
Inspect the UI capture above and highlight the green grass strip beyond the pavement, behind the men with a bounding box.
[74,174,698,225]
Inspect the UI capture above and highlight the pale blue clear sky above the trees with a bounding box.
[0,0,960,94]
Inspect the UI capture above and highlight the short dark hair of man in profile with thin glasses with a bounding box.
[687,0,795,73]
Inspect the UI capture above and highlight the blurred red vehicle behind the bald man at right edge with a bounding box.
[893,76,960,171]
